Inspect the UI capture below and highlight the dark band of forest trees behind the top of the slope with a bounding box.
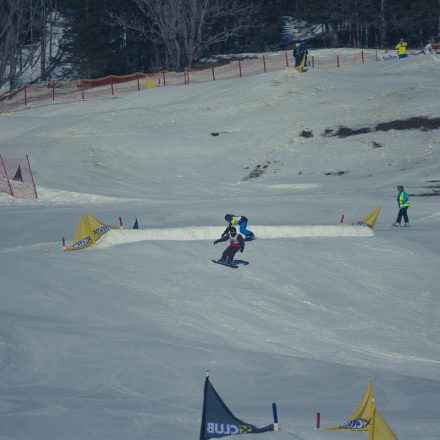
[0,0,440,89]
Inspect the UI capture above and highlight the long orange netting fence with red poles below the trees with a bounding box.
[0,51,378,113]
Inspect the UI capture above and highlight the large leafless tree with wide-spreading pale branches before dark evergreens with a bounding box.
[112,0,259,70]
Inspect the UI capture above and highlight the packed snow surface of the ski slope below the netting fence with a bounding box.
[0,49,440,440]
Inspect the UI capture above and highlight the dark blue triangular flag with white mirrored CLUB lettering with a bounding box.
[200,377,274,440]
